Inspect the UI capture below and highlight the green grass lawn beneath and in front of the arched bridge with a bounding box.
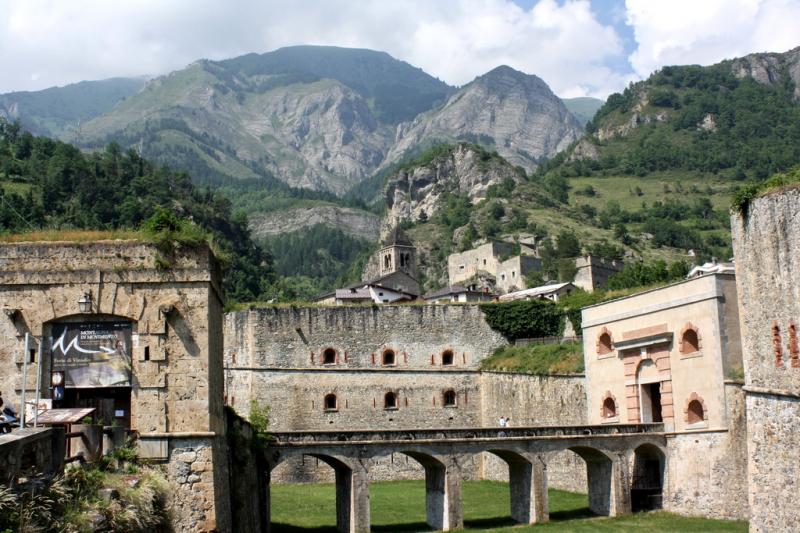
[271,481,747,533]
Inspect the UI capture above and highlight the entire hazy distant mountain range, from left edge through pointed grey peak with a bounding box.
[0,46,580,196]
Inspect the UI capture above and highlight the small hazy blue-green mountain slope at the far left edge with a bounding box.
[0,78,145,140]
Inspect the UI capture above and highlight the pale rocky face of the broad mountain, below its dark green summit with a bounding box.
[83,61,390,193]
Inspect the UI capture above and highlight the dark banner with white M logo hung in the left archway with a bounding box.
[53,322,131,388]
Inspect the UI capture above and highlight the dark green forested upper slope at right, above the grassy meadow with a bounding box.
[576,62,800,180]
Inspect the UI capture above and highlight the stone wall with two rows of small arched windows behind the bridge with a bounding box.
[224,305,586,490]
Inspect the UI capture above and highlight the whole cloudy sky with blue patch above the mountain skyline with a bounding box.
[0,0,800,98]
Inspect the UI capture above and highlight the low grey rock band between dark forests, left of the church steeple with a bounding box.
[249,205,380,241]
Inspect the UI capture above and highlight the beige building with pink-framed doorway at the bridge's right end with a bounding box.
[582,273,747,518]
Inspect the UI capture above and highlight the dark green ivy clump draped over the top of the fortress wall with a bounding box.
[480,300,564,341]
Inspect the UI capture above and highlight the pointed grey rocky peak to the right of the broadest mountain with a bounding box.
[384,66,583,169]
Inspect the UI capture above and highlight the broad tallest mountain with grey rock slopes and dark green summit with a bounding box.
[75,46,451,194]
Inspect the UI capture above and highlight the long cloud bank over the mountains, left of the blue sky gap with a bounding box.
[0,0,626,96]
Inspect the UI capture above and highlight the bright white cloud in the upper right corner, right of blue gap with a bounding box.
[626,0,800,77]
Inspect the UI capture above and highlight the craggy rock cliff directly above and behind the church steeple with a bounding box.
[384,143,522,227]
